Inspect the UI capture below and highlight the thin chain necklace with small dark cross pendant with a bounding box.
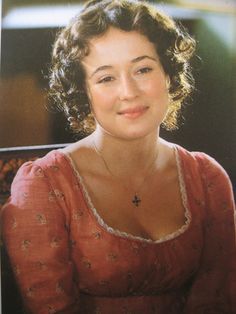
[93,142,158,207]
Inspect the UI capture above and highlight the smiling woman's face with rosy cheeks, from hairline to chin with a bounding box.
[82,27,169,139]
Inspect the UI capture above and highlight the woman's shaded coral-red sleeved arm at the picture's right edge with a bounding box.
[186,154,236,314]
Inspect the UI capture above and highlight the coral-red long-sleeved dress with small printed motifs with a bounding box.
[1,145,236,314]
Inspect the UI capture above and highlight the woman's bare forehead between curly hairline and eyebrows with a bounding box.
[83,27,157,63]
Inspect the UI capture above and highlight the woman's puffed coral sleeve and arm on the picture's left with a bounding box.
[1,163,79,314]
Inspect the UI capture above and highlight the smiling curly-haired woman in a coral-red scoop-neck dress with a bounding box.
[2,0,236,314]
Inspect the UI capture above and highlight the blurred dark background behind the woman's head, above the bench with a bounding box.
[0,0,236,182]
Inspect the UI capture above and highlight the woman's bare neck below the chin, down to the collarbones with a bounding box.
[91,129,160,178]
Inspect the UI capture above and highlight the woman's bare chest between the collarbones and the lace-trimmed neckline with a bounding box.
[80,170,186,240]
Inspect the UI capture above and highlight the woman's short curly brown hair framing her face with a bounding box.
[49,0,195,135]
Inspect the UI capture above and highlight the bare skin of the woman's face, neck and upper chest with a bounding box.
[65,28,185,239]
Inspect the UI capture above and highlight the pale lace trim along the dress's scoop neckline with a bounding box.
[57,144,192,244]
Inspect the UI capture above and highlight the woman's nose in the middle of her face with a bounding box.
[119,76,139,100]
